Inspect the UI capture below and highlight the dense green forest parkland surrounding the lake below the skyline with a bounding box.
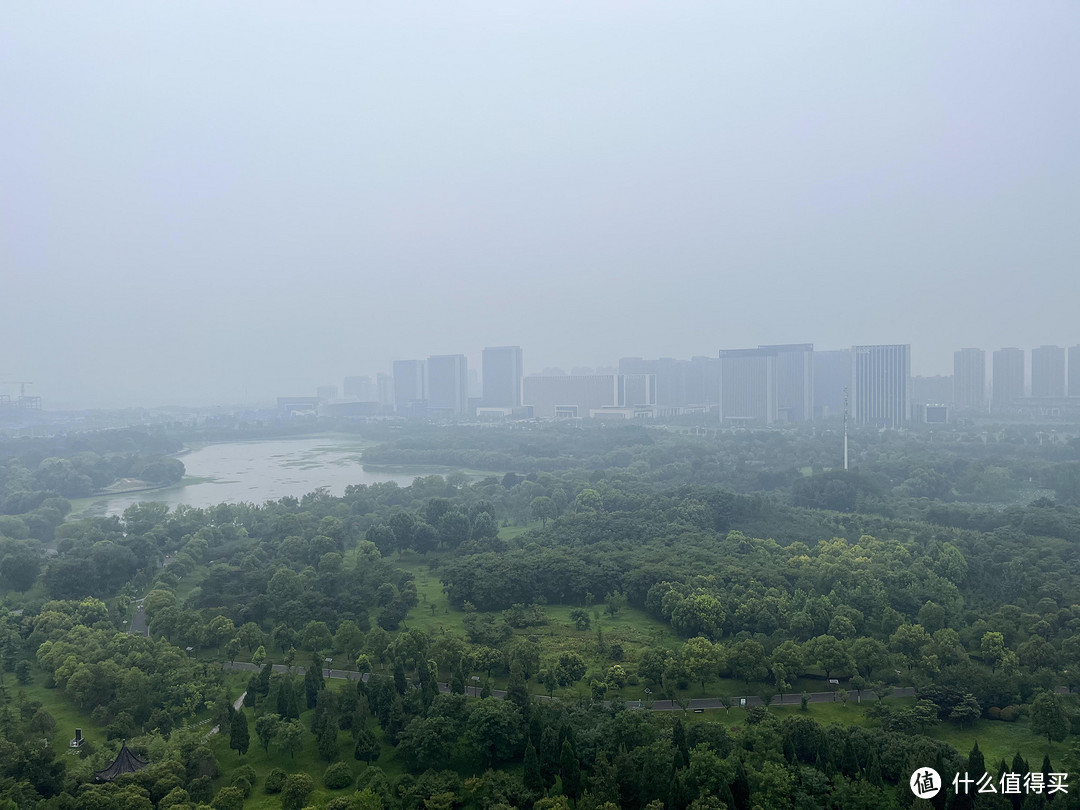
[0,423,1080,810]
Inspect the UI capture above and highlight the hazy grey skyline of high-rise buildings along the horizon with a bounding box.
[280,343,1080,427]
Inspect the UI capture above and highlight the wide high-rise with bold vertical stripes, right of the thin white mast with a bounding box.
[851,343,912,428]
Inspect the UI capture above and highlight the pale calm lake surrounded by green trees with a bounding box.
[75,436,464,516]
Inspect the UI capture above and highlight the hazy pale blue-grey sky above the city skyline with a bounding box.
[0,0,1080,407]
